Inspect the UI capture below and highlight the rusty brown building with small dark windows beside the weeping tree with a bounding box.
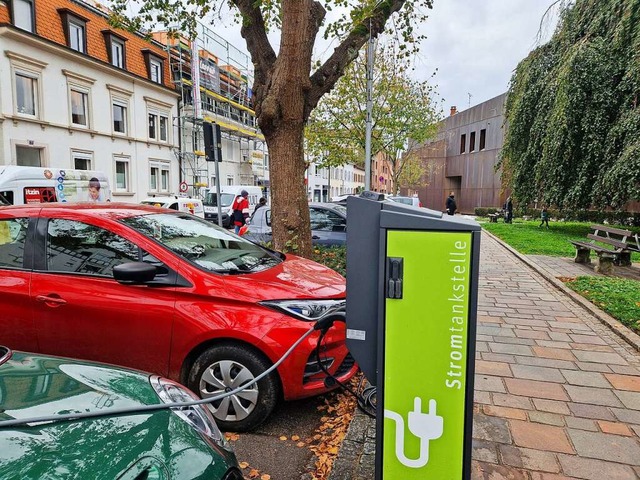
[403,93,508,213]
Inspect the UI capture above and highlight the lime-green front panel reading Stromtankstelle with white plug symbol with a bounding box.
[382,231,472,480]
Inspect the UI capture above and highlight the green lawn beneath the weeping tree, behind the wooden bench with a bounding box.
[482,219,640,262]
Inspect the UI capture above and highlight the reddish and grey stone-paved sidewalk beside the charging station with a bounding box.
[330,234,640,480]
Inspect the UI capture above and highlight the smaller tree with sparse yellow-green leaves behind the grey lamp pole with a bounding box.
[305,39,437,190]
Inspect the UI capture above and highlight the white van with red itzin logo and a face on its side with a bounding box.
[0,165,111,205]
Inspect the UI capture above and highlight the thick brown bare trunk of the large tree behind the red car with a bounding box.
[256,0,316,258]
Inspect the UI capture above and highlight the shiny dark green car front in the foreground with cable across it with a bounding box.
[0,346,243,480]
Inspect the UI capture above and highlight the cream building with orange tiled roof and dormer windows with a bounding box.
[0,0,180,202]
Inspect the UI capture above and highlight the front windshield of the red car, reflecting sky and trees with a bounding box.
[122,213,282,274]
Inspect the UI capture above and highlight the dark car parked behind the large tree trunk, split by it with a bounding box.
[244,203,347,246]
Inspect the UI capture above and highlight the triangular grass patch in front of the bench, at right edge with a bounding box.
[565,276,640,332]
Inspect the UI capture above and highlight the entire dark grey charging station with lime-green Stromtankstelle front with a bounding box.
[346,192,481,480]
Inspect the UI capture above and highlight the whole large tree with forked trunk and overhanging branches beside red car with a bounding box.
[112,0,432,256]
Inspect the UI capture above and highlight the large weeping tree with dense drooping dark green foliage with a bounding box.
[500,0,640,210]
